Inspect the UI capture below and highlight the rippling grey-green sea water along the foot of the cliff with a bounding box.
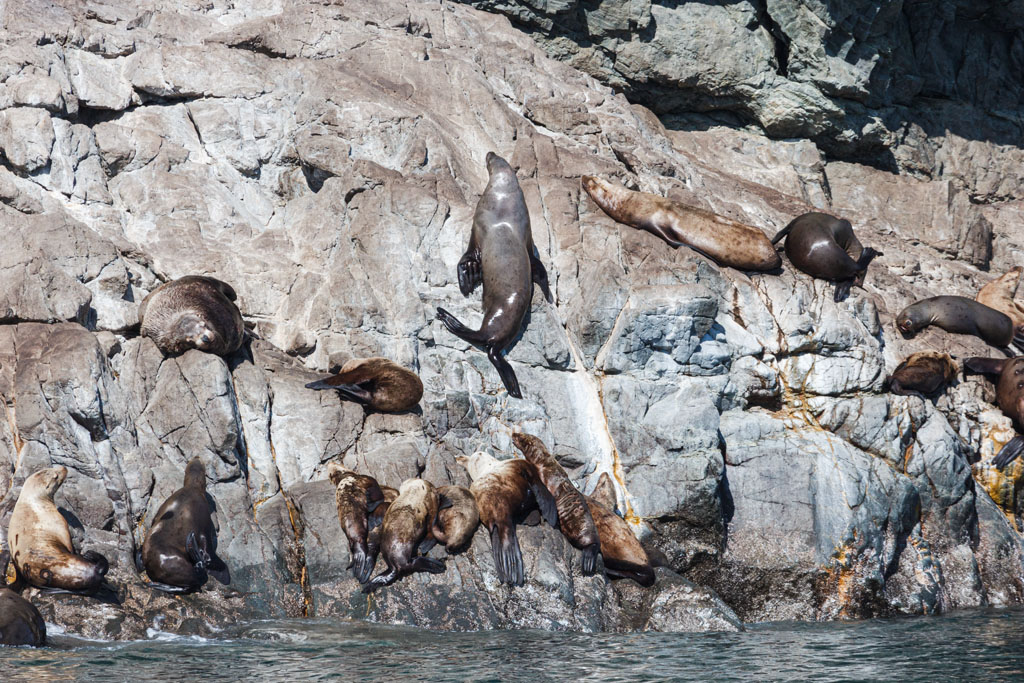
[0,609,1024,683]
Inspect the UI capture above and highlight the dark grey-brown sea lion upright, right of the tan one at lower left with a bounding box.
[135,456,230,593]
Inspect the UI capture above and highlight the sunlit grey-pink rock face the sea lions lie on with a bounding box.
[0,0,1024,638]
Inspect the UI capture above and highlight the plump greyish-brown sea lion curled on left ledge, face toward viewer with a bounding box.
[138,275,246,355]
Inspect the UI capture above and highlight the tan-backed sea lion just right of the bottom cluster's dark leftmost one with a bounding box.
[362,479,444,593]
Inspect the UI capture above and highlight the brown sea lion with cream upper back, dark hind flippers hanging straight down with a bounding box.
[456,452,558,586]
